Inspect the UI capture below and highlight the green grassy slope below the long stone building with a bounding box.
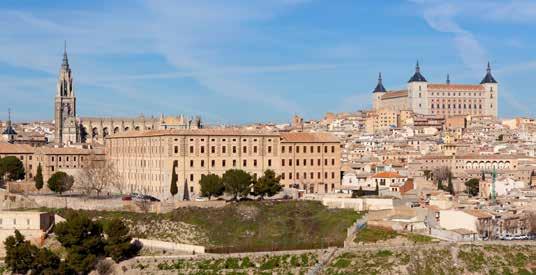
[51,201,361,252]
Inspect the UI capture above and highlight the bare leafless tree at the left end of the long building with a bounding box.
[76,160,122,197]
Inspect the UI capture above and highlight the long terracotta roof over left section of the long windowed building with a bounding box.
[107,129,279,139]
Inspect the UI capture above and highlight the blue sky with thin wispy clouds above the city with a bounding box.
[0,0,536,124]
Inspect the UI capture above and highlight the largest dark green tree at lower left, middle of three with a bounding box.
[54,212,105,274]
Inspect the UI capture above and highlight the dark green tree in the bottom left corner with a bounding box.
[4,230,60,274]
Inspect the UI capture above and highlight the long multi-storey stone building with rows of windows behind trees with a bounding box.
[106,129,340,197]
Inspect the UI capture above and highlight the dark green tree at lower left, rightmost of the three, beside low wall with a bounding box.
[104,218,141,263]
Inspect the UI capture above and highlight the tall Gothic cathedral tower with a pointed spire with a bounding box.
[54,43,80,145]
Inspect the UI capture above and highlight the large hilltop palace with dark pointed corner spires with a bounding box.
[372,62,499,117]
